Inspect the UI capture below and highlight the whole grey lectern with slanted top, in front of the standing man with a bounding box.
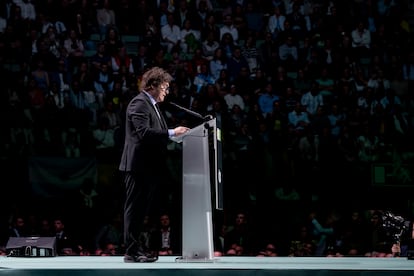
[171,118,221,262]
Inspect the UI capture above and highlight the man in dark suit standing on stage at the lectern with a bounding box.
[119,67,189,262]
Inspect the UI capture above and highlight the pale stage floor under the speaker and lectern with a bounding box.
[0,256,414,276]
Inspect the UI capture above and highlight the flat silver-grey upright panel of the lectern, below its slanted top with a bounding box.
[182,131,214,261]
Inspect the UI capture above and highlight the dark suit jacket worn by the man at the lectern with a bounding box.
[119,92,168,172]
